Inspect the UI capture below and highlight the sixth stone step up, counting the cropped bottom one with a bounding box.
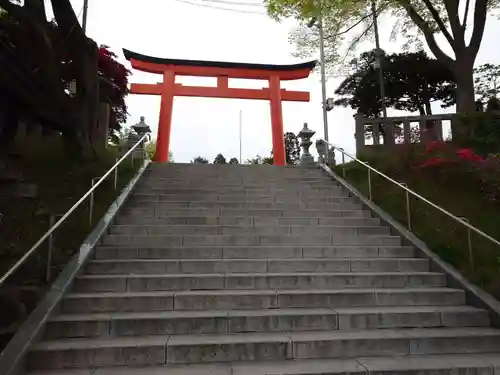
[85,258,429,275]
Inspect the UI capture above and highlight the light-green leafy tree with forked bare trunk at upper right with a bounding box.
[266,0,499,112]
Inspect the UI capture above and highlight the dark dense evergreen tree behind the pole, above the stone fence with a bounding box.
[334,51,455,117]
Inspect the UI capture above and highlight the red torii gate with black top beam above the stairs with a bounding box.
[123,49,316,165]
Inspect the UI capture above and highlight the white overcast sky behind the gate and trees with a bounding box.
[72,0,500,162]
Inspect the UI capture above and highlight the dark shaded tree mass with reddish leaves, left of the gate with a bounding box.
[0,0,129,155]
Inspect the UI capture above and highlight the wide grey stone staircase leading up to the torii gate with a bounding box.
[27,164,500,375]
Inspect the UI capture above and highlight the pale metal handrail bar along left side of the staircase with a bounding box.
[0,134,148,286]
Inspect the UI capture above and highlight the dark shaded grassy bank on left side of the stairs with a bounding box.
[0,138,140,350]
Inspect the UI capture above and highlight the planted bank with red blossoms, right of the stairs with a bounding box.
[337,142,500,298]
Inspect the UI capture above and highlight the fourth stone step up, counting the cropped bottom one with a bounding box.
[61,287,465,313]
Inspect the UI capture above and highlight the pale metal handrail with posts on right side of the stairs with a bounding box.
[322,140,500,269]
